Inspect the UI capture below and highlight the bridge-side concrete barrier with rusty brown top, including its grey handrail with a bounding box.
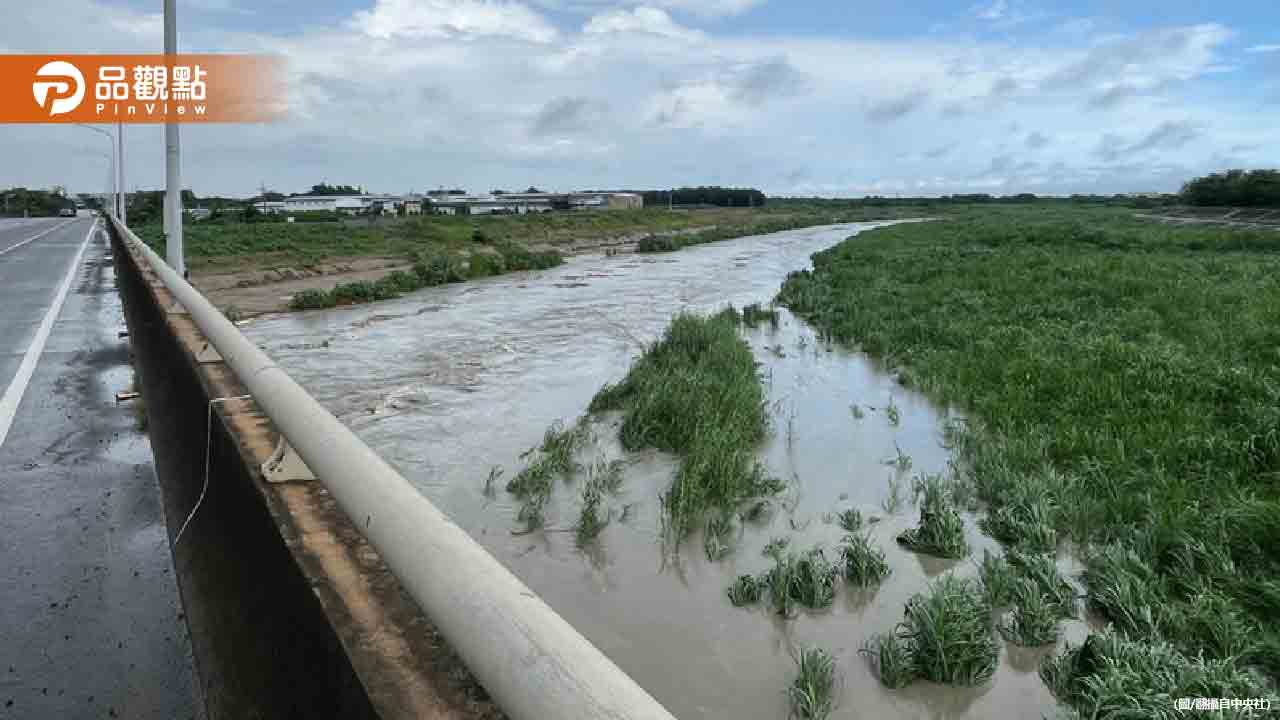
[111,220,671,720]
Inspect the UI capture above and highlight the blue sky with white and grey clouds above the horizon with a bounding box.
[0,0,1280,196]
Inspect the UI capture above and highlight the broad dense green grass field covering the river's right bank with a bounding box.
[778,208,1280,716]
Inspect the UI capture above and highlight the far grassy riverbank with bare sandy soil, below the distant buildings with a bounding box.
[136,205,926,316]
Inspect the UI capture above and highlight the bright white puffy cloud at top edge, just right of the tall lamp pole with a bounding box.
[352,0,557,42]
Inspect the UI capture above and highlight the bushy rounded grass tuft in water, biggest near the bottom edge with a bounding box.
[861,574,998,688]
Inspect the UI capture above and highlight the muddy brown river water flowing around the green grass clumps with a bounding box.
[246,223,1087,720]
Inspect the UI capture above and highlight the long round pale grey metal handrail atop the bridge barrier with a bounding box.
[110,217,673,720]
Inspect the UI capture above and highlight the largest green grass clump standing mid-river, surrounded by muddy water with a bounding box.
[590,310,782,539]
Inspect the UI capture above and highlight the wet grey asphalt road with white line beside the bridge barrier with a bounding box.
[0,218,204,720]
